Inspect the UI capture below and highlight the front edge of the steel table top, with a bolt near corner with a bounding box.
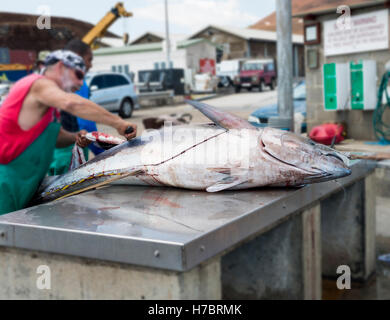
[0,222,184,271]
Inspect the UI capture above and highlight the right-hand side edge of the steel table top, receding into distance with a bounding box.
[183,160,376,270]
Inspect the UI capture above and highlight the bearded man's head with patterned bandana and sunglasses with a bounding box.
[45,50,86,92]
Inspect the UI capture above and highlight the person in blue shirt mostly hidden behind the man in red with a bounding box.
[49,39,104,175]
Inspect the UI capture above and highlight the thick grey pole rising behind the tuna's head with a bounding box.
[276,0,294,131]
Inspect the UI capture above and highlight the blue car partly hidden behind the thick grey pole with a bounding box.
[248,81,307,132]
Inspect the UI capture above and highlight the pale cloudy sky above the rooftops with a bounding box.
[0,0,275,40]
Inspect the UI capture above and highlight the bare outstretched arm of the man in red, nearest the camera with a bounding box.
[31,79,137,139]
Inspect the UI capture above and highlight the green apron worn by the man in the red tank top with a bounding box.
[0,122,60,215]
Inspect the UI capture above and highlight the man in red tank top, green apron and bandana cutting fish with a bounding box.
[0,50,136,215]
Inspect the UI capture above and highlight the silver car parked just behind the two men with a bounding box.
[85,72,140,118]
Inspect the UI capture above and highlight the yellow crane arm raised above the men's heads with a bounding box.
[83,2,133,48]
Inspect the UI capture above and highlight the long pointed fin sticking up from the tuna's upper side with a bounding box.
[185,100,256,130]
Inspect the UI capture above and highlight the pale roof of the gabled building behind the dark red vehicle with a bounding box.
[188,24,303,43]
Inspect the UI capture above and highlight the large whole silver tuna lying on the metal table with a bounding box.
[35,101,351,203]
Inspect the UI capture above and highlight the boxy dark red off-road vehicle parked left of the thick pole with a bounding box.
[234,59,276,92]
